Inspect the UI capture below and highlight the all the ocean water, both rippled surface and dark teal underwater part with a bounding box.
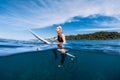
[0,39,120,80]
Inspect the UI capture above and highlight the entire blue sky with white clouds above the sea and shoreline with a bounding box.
[0,0,120,40]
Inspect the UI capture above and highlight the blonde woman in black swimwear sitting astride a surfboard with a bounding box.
[56,26,67,67]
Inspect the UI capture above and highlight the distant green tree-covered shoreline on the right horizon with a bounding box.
[66,31,120,40]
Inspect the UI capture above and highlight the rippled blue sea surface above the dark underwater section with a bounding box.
[0,39,120,56]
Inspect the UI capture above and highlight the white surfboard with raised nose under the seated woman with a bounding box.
[29,29,75,58]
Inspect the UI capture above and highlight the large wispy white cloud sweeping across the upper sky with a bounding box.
[0,0,120,28]
